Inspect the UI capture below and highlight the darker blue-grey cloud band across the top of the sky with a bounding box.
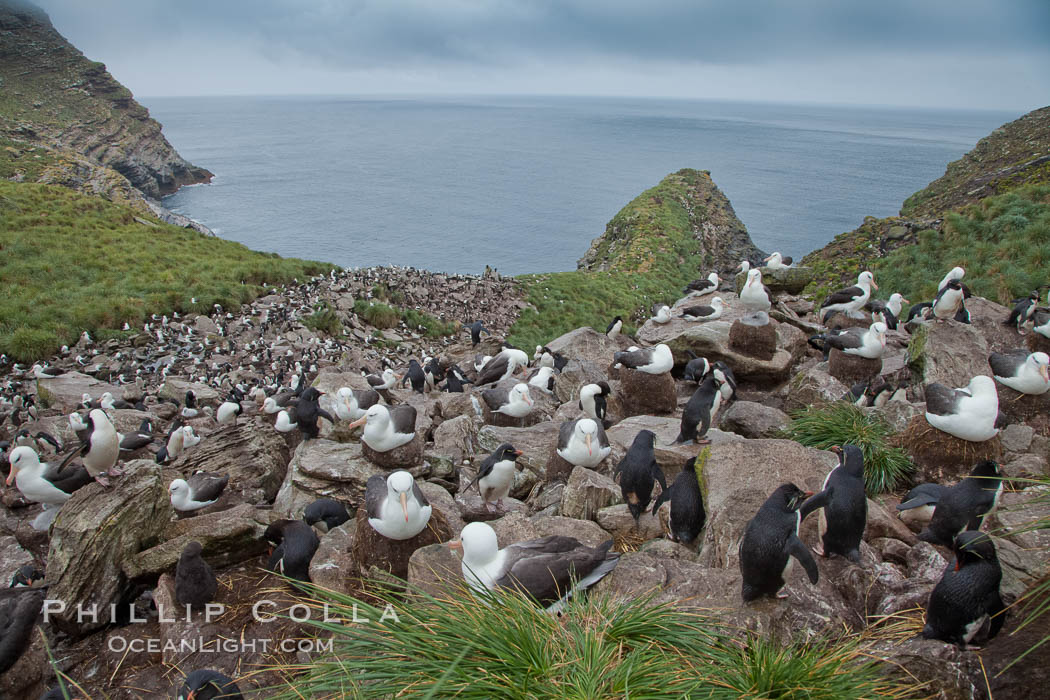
[41,0,1050,68]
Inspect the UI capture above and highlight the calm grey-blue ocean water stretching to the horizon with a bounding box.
[143,97,1020,274]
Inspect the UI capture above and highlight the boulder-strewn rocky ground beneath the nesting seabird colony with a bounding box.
[0,264,1050,698]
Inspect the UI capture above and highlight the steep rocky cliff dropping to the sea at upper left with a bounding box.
[0,0,211,200]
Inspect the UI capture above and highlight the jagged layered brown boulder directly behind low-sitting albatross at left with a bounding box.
[172,419,292,505]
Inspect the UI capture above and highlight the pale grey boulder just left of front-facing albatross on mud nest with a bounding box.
[273,439,387,519]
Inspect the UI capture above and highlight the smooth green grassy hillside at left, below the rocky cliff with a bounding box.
[0,181,332,361]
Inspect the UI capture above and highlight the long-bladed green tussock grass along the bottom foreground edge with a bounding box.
[260,588,910,700]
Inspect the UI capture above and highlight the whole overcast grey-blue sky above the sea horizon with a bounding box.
[37,0,1050,111]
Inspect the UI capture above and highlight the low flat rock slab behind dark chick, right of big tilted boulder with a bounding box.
[121,503,275,578]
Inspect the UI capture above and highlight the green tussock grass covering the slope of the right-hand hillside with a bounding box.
[874,184,1050,304]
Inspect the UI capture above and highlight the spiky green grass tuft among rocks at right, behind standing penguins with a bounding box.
[784,401,915,495]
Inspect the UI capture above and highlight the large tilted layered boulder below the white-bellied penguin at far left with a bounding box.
[46,460,172,635]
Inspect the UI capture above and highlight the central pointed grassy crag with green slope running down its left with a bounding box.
[508,169,755,347]
